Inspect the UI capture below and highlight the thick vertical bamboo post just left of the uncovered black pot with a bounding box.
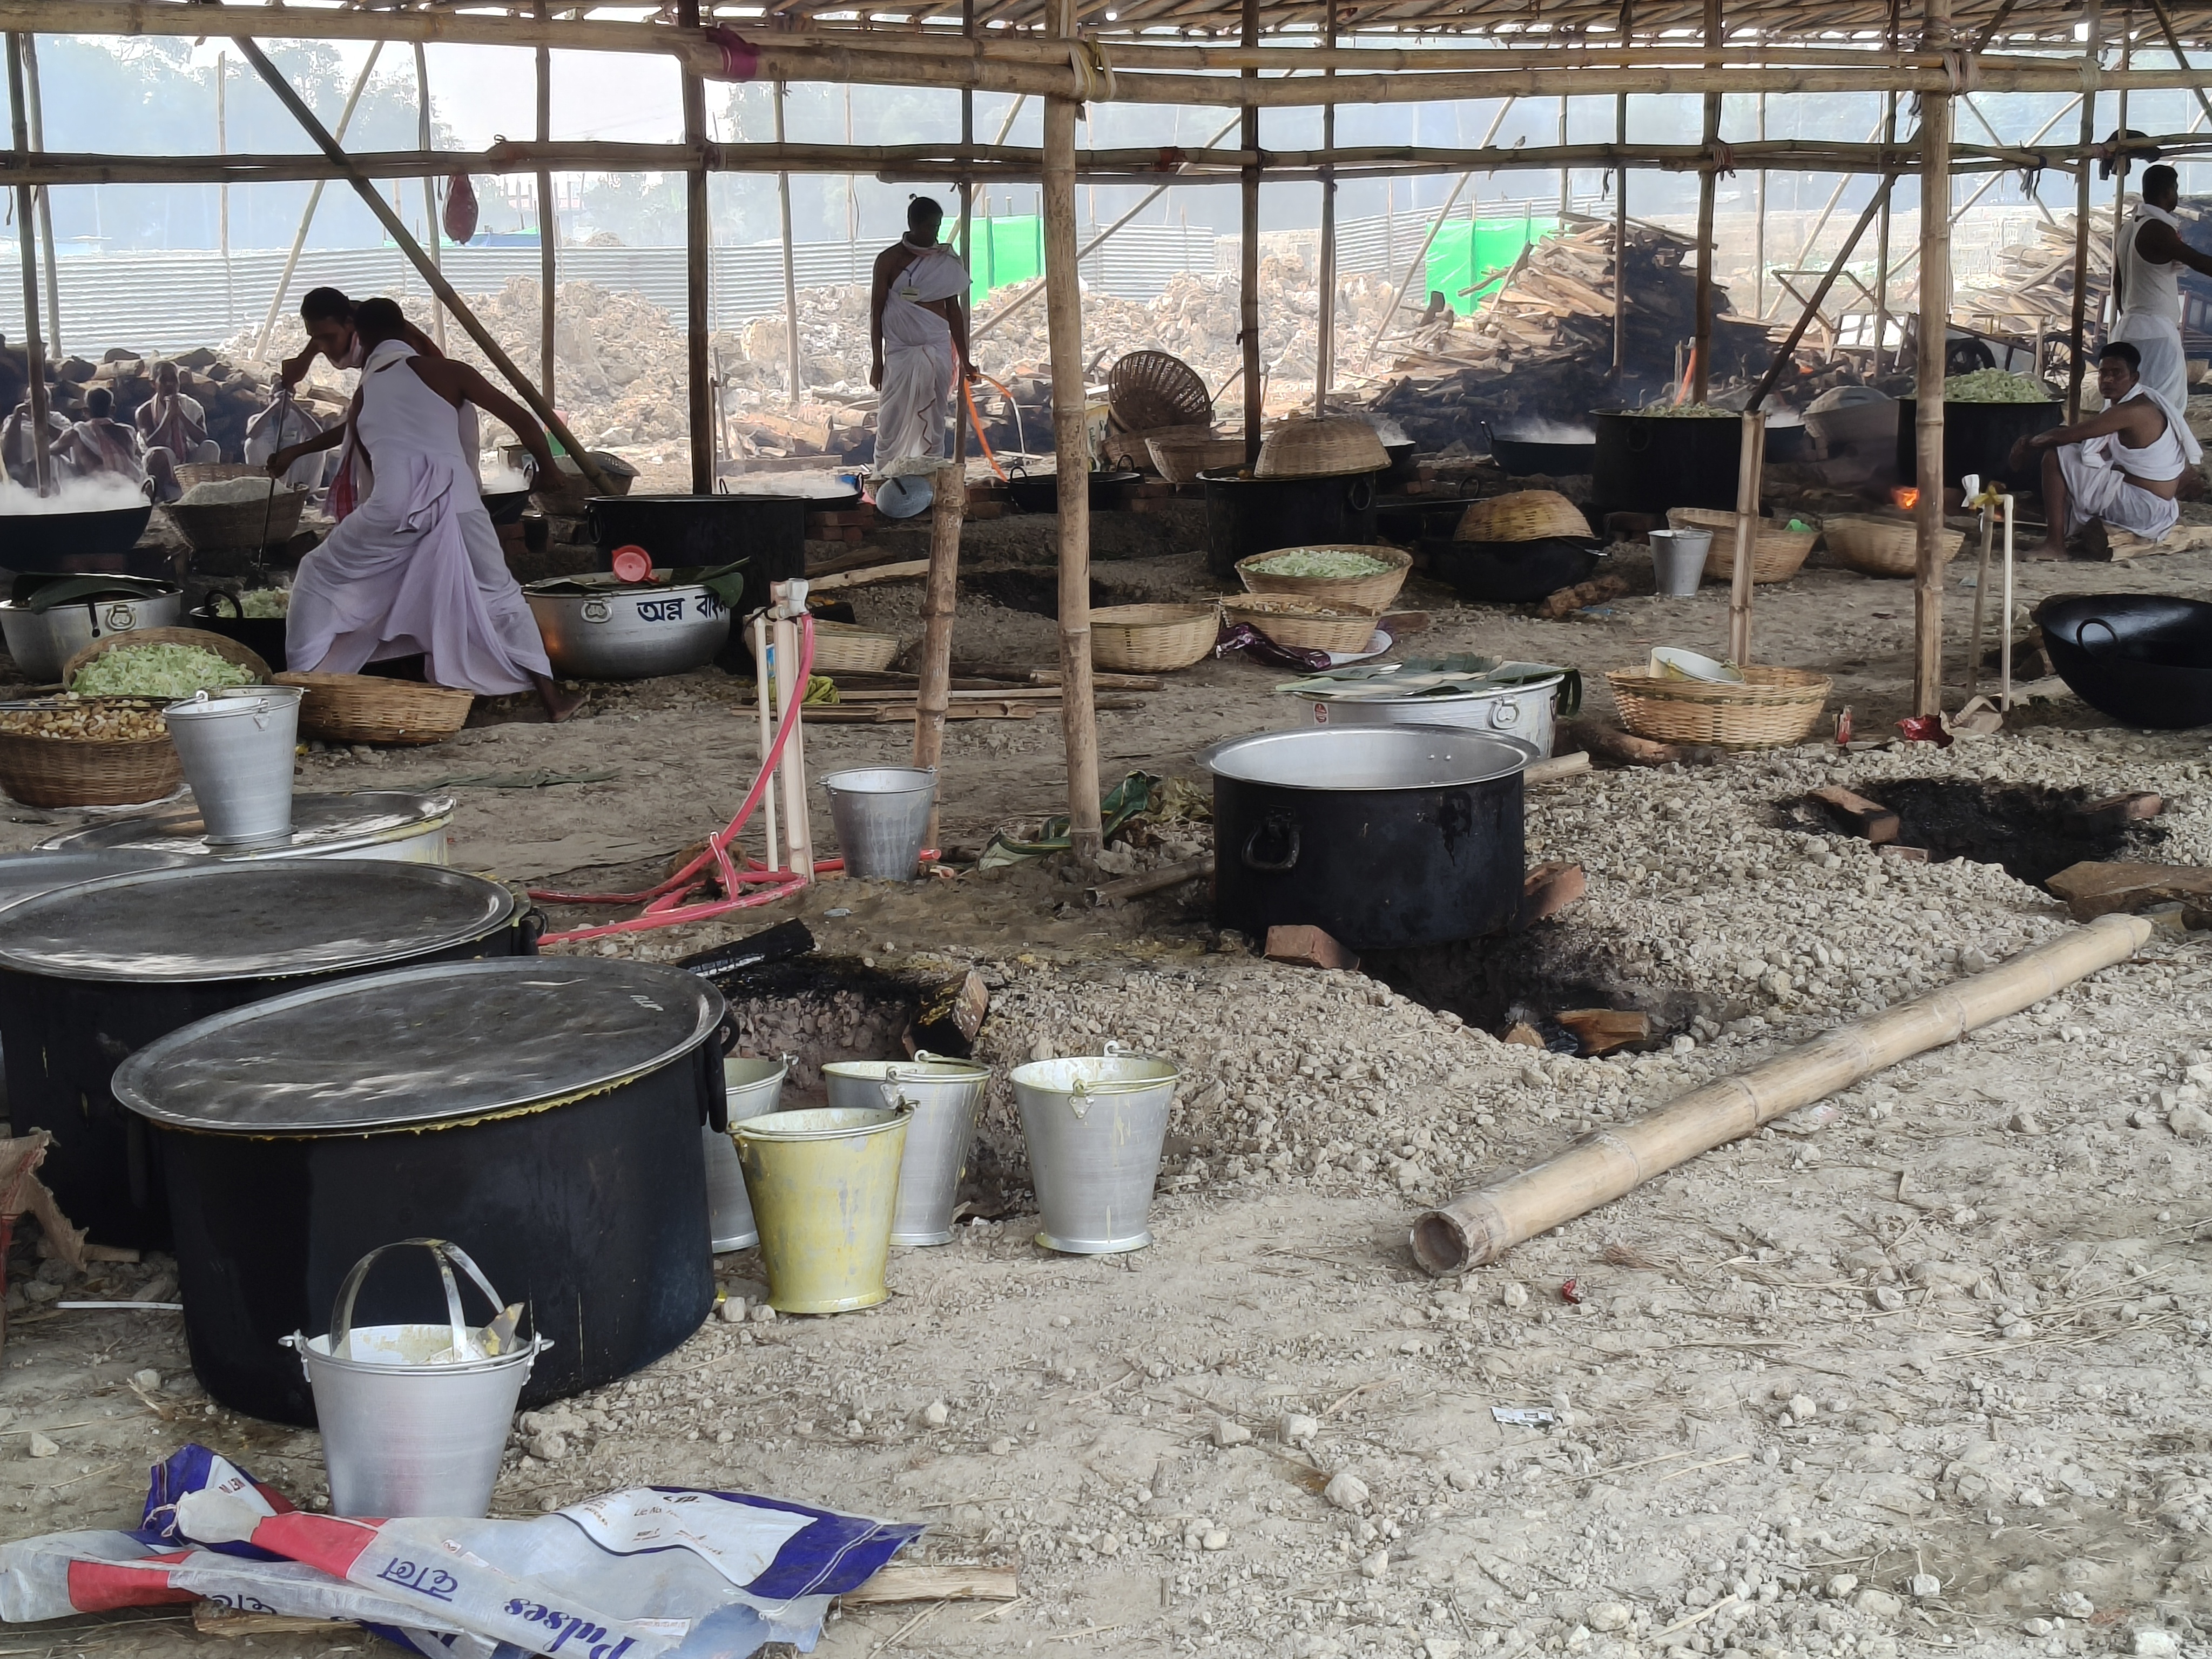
[1044,0,1101,865]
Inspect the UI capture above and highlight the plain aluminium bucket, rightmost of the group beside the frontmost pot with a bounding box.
[1013,1042,1183,1257]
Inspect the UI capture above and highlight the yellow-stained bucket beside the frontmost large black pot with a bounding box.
[730,1106,909,1314]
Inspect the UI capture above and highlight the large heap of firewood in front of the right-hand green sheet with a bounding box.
[1369,224,1772,449]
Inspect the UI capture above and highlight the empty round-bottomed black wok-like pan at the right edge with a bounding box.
[2035,593,2212,732]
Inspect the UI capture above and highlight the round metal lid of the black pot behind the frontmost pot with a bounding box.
[0,858,515,984]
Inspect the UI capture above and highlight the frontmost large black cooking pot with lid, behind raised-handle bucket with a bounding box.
[115,958,725,1422]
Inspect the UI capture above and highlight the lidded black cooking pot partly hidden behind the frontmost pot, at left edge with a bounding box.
[0,854,537,1247]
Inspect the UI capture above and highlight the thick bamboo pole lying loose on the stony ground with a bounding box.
[1413,916,2150,1274]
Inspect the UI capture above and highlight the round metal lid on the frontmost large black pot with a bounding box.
[115,955,725,1135]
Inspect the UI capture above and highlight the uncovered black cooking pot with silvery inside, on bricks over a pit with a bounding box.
[1203,725,1533,951]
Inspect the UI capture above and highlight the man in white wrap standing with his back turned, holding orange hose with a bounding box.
[867,197,975,517]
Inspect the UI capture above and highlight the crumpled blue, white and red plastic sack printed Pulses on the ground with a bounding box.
[0,1447,920,1659]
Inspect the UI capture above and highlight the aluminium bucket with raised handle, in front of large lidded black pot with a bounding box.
[283,1239,551,1520]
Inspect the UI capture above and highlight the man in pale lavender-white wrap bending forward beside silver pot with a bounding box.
[268,299,582,721]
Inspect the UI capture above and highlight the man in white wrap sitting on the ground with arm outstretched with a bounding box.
[2006,341,2203,559]
